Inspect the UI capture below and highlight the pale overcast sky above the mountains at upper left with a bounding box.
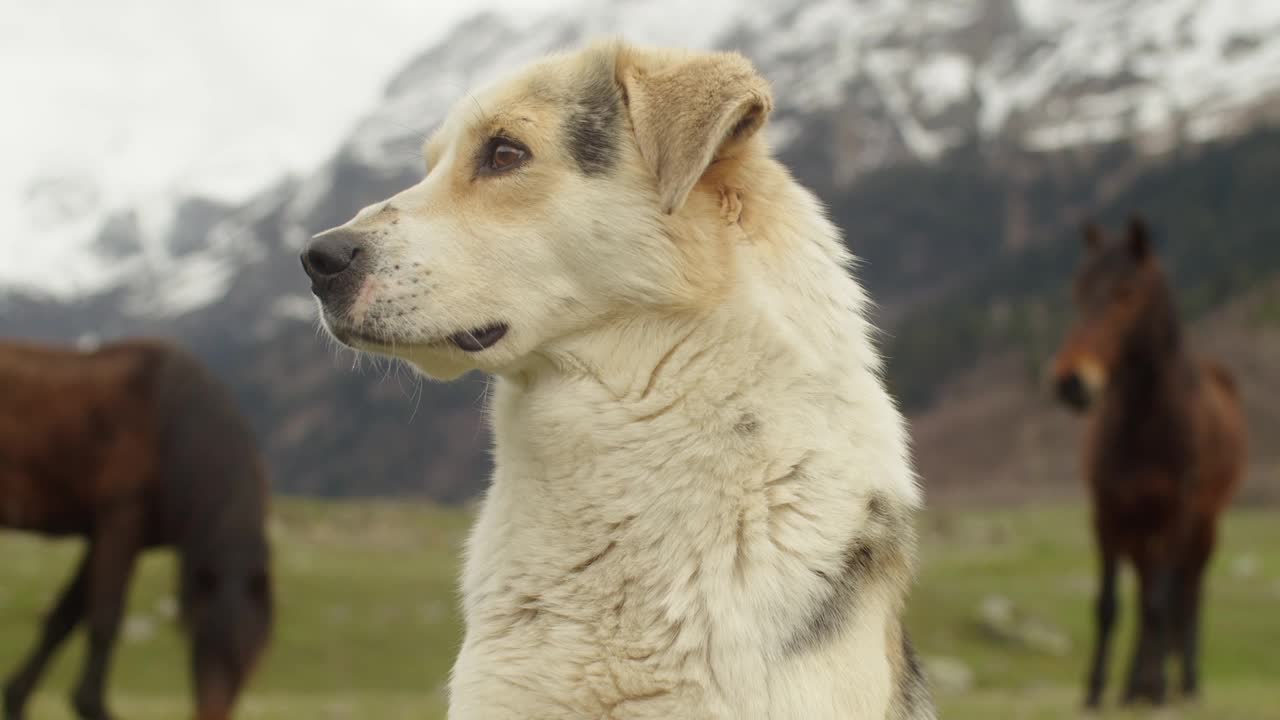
[0,0,567,245]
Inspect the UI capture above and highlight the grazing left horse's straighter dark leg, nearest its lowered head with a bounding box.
[73,507,142,720]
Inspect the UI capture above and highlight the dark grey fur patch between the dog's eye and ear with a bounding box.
[564,64,622,176]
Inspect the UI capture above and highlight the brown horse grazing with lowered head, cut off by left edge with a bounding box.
[0,341,273,720]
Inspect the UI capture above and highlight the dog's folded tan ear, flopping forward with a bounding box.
[617,47,773,214]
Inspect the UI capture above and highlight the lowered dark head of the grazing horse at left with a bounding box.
[182,543,274,720]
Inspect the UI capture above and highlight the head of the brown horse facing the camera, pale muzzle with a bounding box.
[1052,218,1170,411]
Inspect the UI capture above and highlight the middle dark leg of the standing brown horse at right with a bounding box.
[1124,552,1172,705]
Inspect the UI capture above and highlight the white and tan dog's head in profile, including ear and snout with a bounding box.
[302,42,771,379]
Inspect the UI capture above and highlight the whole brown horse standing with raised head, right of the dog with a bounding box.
[1053,218,1245,707]
